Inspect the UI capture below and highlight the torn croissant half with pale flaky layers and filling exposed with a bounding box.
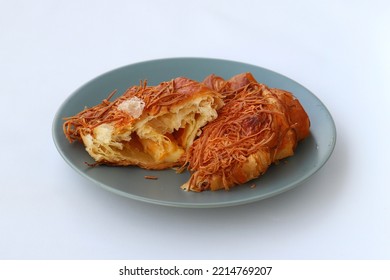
[63,77,223,169]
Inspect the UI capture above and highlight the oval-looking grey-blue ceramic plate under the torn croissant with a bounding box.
[53,58,336,208]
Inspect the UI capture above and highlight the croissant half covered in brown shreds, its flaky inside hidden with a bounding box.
[182,73,310,192]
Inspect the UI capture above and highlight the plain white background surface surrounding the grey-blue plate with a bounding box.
[0,0,390,259]
